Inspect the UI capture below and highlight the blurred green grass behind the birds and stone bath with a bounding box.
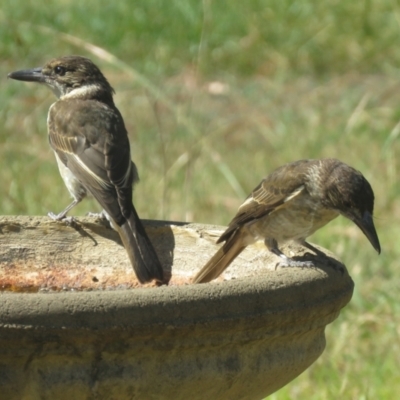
[0,0,400,400]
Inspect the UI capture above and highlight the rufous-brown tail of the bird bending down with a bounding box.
[193,236,246,283]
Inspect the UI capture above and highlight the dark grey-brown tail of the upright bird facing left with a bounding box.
[115,206,164,283]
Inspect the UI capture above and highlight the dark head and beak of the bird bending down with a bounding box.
[324,161,381,253]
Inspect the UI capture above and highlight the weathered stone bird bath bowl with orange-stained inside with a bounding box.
[0,217,353,400]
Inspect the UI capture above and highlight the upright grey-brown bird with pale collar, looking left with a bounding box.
[8,56,163,283]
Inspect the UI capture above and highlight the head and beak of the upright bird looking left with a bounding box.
[8,56,114,98]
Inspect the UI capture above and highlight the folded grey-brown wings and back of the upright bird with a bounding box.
[48,100,137,220]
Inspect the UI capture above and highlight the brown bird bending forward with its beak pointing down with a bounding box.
[193,158,381,283]
